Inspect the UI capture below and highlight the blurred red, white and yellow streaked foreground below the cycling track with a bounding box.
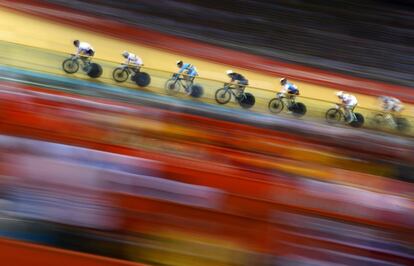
[0,83,414,265]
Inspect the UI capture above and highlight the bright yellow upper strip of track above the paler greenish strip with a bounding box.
[0,2,410,107]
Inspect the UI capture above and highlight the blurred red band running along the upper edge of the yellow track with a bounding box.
[0,0,414,103]
